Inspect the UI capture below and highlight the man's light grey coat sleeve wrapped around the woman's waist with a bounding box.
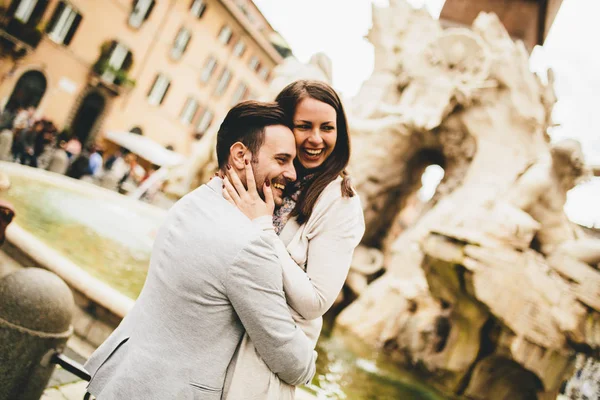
[224,237,315,385]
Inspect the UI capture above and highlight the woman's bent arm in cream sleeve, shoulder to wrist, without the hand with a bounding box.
[255,197,365,320]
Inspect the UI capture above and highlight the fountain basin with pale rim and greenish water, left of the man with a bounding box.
[0,162,166,304]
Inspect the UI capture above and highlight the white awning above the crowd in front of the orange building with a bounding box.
[104,131,186,167]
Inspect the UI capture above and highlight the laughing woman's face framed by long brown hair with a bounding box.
[294,97,337,169]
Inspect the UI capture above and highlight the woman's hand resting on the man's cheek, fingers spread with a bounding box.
[223,160,275,220]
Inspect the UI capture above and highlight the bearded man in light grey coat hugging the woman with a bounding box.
[85,101,315,400]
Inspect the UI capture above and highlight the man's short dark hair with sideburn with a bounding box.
[217,100,291,168]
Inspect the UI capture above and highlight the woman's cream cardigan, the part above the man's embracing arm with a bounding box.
[254,178,365,345]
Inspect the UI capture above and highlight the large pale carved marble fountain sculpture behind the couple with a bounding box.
[163,0,600,399]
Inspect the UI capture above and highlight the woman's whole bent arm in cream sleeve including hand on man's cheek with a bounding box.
[223,162,365,320]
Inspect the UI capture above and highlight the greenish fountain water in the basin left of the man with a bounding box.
[0,176,162,299]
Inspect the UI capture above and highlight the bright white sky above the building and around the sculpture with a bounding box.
[254,0,600,227]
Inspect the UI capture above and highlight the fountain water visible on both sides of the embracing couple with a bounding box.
[0,167,446,400]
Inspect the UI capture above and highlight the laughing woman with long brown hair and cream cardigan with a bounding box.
[223,80,365,400]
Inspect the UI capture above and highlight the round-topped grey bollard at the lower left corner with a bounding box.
[0,268,74,400]
